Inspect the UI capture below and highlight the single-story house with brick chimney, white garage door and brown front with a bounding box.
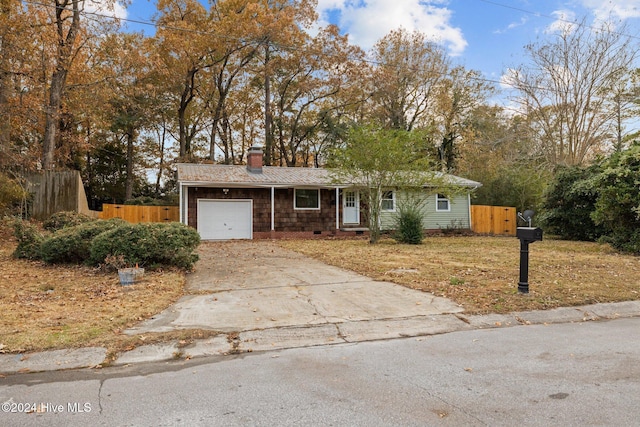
[177,147,481,240]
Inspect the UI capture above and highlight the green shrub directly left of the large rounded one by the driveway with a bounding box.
[40,218,127,264]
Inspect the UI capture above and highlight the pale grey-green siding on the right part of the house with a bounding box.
[380,192,471,230]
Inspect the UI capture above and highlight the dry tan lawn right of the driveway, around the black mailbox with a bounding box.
[281,236,640,313]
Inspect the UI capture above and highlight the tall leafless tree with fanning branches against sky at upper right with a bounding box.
[508,20,637,169]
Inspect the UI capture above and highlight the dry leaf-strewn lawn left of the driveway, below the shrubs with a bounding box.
[0,230,220,355]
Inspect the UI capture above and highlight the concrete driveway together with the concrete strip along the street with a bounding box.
[0,241,640,373]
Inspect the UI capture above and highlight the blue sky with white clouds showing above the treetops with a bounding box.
[112,0,640,92]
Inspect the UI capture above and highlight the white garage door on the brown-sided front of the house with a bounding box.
[198,200,253,240]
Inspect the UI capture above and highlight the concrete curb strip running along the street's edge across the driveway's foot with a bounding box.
[0,301,640,374]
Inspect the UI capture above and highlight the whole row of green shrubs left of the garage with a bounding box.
[14,215,200,269]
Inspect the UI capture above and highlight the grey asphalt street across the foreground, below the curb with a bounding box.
[0,317,640,426]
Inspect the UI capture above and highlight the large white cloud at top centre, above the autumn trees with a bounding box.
[318,0,467,56]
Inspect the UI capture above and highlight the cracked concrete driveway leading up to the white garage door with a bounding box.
[127,240,462,334]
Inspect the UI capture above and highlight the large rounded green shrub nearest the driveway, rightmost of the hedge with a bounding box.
[90,223,200,269]
